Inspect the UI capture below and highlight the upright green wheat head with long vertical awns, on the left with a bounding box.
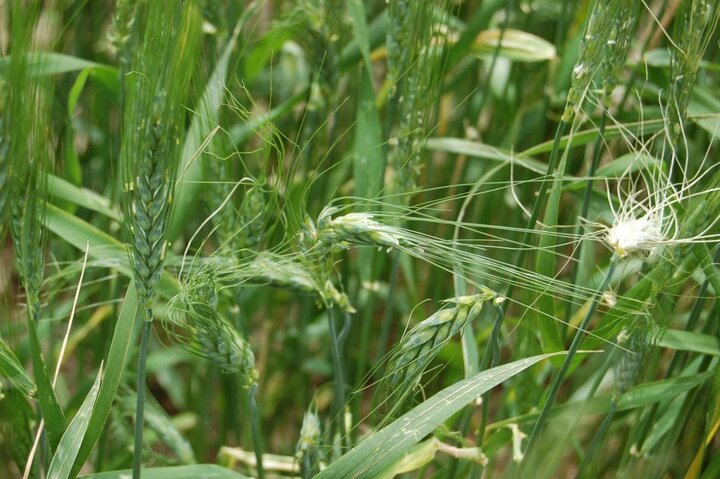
[120,2,199,309]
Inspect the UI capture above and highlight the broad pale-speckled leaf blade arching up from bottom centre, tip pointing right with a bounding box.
[316,353,563,479]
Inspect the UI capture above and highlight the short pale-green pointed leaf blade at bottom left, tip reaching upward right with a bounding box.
[47,365,102,479]
